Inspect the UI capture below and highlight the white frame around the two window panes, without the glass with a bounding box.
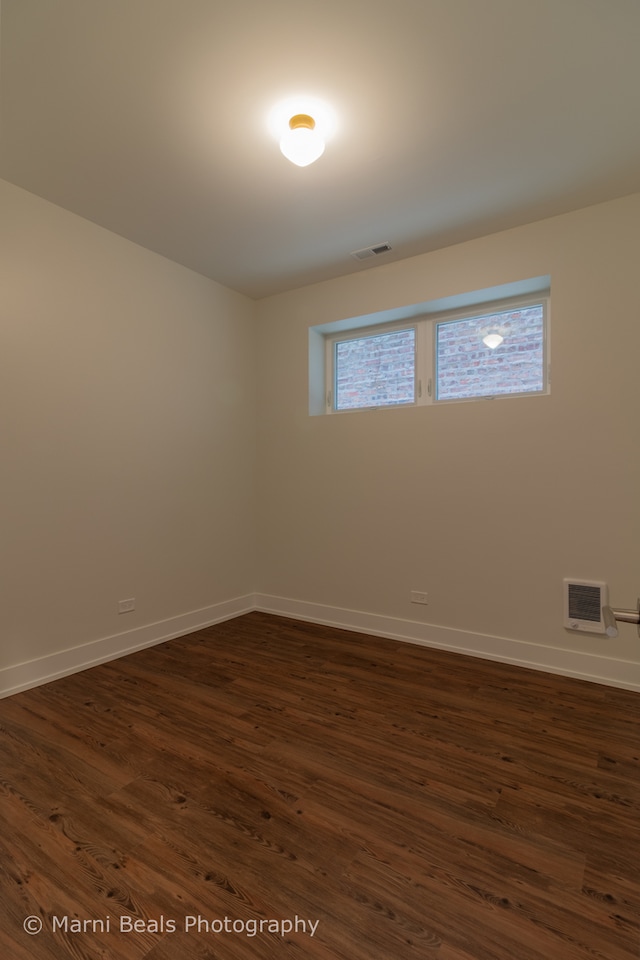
[324,291,551,415]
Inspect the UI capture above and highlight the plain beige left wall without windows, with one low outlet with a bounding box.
[0,183,256,681]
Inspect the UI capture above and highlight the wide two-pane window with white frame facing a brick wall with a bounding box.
[317,291,549,413]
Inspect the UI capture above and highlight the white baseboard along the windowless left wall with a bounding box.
[0,594,255,699]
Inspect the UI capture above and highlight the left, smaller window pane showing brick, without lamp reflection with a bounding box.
[335,328,416,410]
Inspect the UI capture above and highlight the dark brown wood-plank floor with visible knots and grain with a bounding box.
[0,613,640,960]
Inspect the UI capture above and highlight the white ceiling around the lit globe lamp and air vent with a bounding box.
[0,0,640,297]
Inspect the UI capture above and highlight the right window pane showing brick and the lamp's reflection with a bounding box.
[436,304,545,400]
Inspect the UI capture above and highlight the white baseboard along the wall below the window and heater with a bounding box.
[254,593,640,691]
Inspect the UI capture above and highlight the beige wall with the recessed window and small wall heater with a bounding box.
[258,196,640,672]
